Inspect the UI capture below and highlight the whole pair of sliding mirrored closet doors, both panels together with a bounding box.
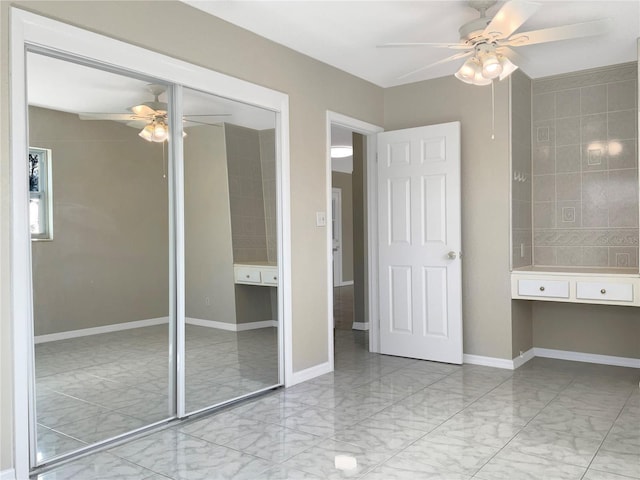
[27,52,282,467]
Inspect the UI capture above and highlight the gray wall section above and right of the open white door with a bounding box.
[384,76,512,359]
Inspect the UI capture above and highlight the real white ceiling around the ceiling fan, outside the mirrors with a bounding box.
[183,0,640,87]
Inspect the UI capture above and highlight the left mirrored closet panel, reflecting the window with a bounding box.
[27,52,175,464]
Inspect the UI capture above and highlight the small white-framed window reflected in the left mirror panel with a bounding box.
[29,147,53,240]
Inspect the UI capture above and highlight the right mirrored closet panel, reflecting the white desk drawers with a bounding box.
[184,88,280,412]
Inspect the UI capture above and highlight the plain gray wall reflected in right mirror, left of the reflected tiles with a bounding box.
[184,125,236,323]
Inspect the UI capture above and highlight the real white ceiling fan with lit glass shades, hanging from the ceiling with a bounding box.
[380,0,612,85]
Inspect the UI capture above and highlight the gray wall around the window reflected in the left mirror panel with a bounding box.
[29,107,169,335]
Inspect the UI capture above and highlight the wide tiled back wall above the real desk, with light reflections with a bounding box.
[532,63,638,267]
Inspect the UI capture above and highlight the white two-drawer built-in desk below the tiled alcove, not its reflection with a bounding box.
[511,267,640,307]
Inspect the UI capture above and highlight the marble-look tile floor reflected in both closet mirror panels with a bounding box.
[35,325,278,461]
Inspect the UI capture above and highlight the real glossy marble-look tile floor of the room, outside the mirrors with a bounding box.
[38,330,640,480]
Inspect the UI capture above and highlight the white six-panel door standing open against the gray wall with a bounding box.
[378,122,462,364]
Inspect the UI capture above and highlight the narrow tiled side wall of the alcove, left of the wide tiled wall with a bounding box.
[511,70,533,268]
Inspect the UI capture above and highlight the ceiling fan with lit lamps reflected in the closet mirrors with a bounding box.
[78,84,230,142]
